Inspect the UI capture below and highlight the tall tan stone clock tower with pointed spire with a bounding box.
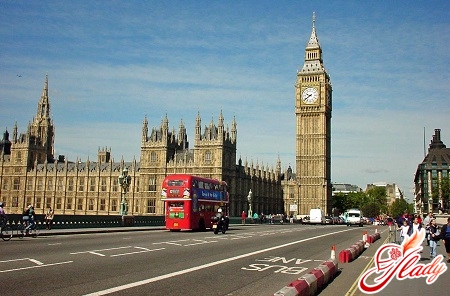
[295,14,332,214]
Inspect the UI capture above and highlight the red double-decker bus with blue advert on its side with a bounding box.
[161,174,229,231]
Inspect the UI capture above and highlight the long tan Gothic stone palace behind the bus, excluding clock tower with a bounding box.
[0,77,284,216]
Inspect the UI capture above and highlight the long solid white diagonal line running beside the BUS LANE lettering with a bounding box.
[85,229,351,296]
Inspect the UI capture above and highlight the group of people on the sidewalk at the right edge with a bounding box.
[397,212,450,263]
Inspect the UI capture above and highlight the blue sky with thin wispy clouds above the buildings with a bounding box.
[0,1,450,198]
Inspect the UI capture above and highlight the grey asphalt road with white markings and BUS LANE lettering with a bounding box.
[0,225,450,296]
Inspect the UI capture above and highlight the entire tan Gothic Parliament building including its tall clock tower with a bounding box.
[0,17,332,216]
